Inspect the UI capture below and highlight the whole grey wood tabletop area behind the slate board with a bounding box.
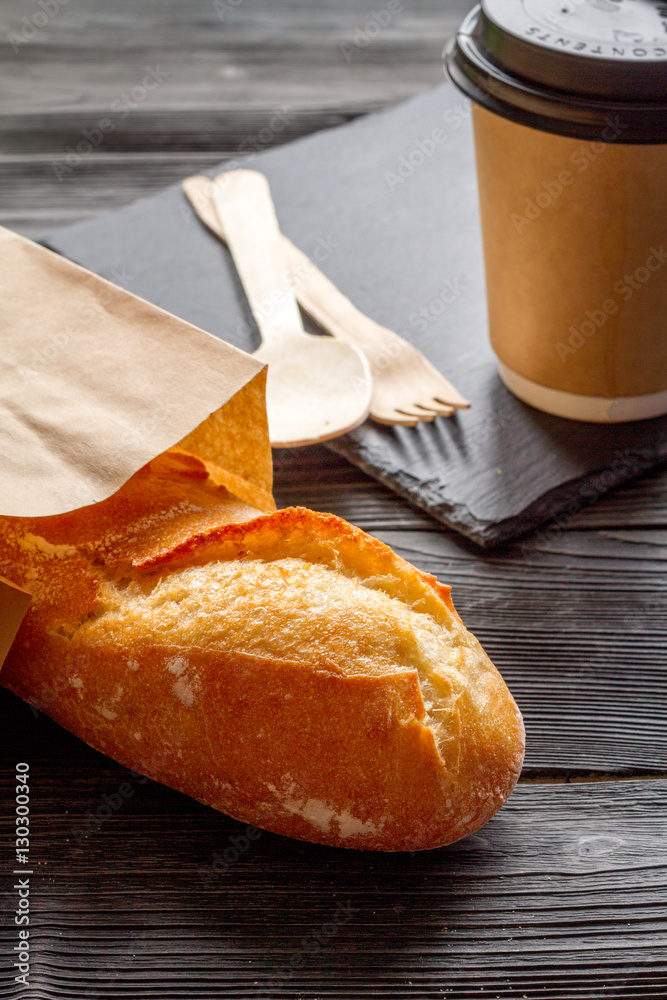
[0,0,470,236]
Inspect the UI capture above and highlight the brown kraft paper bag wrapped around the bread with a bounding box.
[0,228,275,665]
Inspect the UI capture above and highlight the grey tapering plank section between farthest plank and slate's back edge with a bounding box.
[0,107,366,237]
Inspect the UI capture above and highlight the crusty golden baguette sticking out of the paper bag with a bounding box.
[0,454,524,850]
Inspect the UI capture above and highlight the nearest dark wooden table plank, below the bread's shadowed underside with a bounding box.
[0,752,667,1000]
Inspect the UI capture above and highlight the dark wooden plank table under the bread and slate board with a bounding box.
[0,0,667,1000]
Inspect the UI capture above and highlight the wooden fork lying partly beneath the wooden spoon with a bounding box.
[183,174,470,427]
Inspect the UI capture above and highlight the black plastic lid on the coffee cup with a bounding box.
[444,0,667,143]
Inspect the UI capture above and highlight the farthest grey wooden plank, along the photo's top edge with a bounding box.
[0,0,470,114]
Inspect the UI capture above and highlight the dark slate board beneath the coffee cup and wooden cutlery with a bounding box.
[45,84,667,546]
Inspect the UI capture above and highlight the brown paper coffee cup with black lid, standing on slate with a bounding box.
[447,0,667,422]
